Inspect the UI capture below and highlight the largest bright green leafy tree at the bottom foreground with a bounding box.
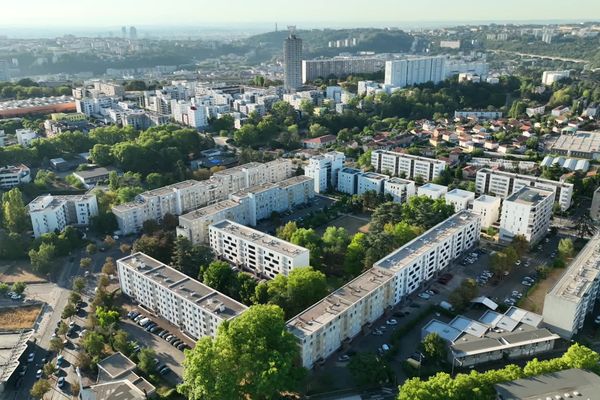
[177,305,304,400]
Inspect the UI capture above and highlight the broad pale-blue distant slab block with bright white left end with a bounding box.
[385,56,445,87]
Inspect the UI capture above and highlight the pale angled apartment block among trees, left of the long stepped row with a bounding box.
[27,194,98,238]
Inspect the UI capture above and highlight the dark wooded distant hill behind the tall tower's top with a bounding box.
[244,29,414,58]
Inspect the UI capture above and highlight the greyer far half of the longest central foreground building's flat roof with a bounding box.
[374,210,479,271]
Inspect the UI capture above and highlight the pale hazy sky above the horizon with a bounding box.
[0,0,600,28]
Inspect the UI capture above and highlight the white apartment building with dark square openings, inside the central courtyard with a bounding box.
[209,220,310,279]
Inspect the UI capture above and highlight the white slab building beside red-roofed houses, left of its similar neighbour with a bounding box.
[371,150,446,182]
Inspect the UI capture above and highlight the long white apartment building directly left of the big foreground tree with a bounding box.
[117,253,247,339]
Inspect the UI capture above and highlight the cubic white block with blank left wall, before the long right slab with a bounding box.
[500,187,553,245]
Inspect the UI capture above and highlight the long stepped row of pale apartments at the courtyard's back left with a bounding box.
[112,159,293,235]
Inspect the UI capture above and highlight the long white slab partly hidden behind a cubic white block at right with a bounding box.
[475,168,573,211]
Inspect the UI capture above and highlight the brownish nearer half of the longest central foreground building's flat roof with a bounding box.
[287,268,393,338]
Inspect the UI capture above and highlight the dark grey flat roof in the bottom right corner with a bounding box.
[494,368,600,400]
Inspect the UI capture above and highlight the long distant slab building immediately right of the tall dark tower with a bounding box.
[302,57,385,83]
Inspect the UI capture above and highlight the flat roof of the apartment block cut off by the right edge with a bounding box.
[547,233,600,303]
